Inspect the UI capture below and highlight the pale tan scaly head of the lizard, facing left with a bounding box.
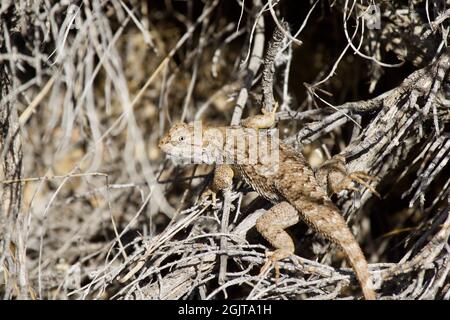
[159,122,227,164]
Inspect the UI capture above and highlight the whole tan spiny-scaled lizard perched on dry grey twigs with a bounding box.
[159,106,376,300]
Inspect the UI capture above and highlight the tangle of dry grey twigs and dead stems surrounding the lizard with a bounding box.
[0,0,450,300]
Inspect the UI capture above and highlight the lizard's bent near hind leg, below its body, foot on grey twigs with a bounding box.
[256,201,299,279]
